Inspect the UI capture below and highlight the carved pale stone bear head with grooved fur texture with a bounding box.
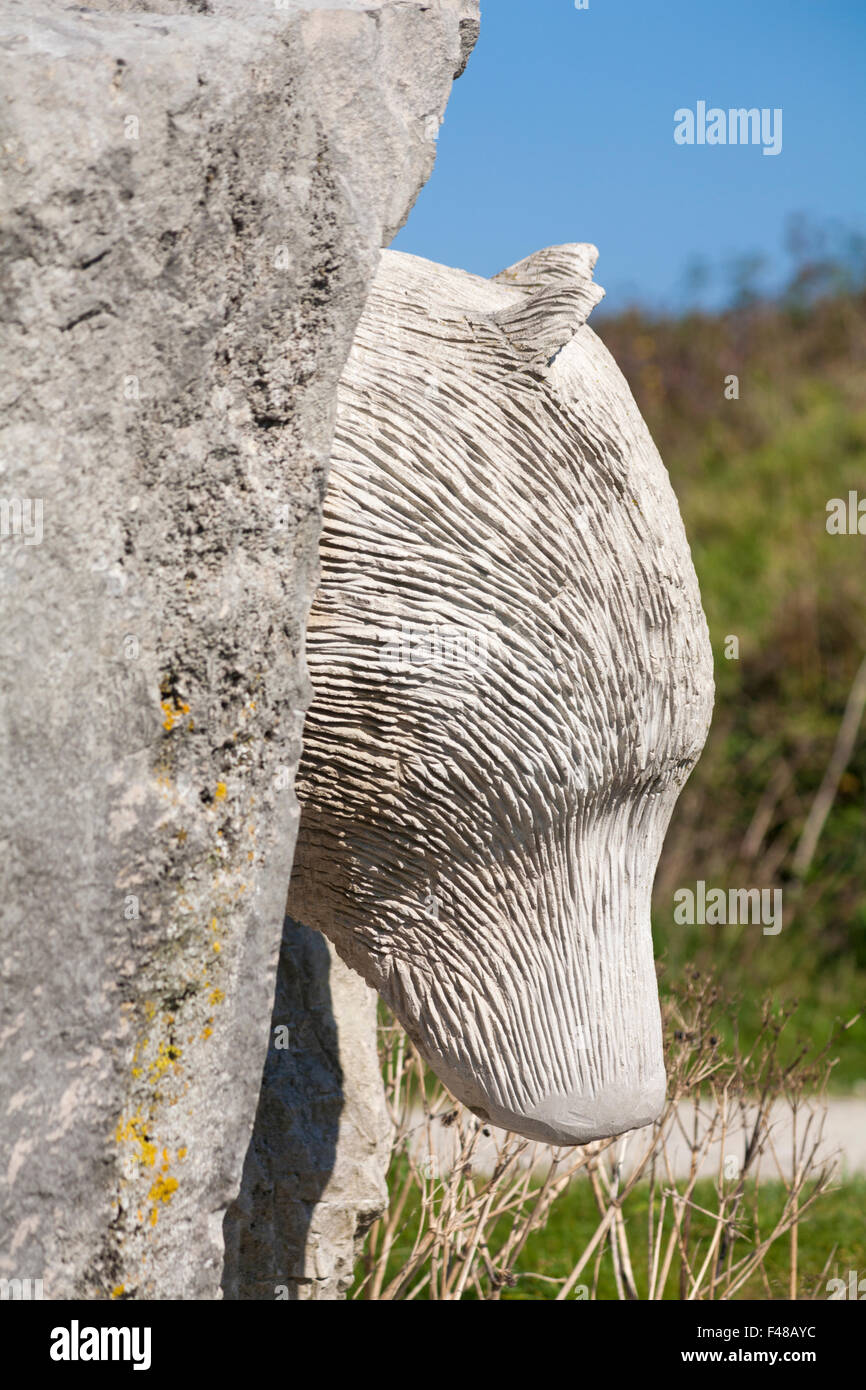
[289,246,713,1144]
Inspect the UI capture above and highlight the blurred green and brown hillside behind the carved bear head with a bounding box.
[599,284,866,1086]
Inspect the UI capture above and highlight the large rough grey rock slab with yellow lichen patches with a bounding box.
[0,0,477,1298]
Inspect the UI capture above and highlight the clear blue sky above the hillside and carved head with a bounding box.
[393,0,866,310]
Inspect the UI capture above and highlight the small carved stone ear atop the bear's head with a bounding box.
[492,242,605,366]
